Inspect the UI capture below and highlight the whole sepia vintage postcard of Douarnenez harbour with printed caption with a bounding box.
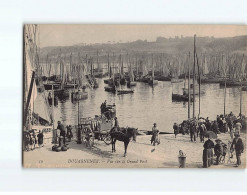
[22,24,247,169]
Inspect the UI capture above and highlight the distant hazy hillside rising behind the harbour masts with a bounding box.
[41,35,247,58]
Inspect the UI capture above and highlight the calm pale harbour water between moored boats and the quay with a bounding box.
[35,79,247,132]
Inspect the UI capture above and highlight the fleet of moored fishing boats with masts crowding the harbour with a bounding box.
[24,25,247,152]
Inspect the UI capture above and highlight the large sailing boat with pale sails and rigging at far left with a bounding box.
[23,25,54,150]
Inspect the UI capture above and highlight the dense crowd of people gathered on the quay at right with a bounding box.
[173,112,245,168]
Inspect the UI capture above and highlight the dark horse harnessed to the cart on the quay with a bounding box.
[110,127,138,157]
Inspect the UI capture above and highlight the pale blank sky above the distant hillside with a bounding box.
[39,24,247,47]
